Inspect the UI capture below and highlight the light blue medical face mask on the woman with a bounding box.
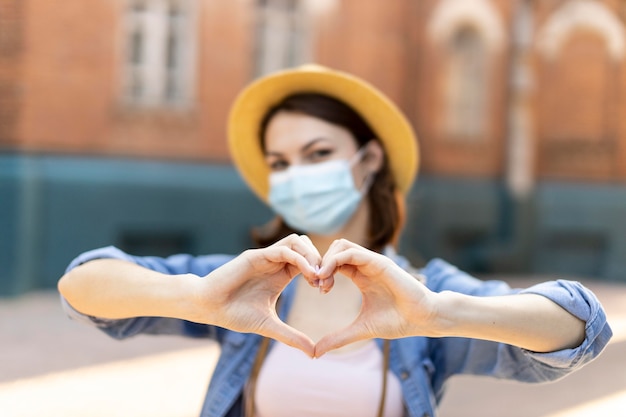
[269,148,371,235]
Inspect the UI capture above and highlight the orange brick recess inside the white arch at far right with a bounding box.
[537,30,619,178]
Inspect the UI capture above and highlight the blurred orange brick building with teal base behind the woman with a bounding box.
[0,0,626,294]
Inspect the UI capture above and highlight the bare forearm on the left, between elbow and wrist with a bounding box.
[58,259,198,319]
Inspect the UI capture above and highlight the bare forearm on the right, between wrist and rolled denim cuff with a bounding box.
[438,292,585,352]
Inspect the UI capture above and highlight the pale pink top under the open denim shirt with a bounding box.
[255,340,404,417]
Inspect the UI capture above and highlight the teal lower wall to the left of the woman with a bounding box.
[0,155,271,295]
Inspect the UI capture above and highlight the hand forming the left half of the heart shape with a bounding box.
[193,235,322,357]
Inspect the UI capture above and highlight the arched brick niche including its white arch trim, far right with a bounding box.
[536,0,626,179]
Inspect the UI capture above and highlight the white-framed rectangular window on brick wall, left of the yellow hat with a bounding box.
[122,0,196,107]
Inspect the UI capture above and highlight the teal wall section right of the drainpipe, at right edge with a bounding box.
[532,183,626,282]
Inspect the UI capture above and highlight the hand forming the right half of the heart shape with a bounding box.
[315,239,437,357]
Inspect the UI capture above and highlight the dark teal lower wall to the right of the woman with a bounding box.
[402,177,626,282]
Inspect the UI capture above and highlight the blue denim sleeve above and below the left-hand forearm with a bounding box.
[61,246,233,339]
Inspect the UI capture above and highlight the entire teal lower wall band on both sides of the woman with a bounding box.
[0,154,626,296]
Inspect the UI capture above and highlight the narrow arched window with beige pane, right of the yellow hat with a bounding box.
[443,26,487,140]
